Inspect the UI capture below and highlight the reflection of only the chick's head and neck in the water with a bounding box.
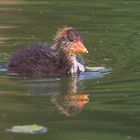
[52,77,89,116]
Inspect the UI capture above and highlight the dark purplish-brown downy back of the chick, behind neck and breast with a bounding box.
[8,43,70,77]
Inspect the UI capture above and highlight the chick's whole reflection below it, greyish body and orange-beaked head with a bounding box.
[25,77,89,116]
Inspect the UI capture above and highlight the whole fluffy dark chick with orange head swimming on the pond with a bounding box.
[7,27,88,77]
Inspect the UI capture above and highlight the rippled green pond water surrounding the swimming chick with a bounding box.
[0,0,140,140]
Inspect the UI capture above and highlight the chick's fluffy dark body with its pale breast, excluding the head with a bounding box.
[8,26,88,77]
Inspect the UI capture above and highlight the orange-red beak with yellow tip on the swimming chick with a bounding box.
[74,41,88,54]
